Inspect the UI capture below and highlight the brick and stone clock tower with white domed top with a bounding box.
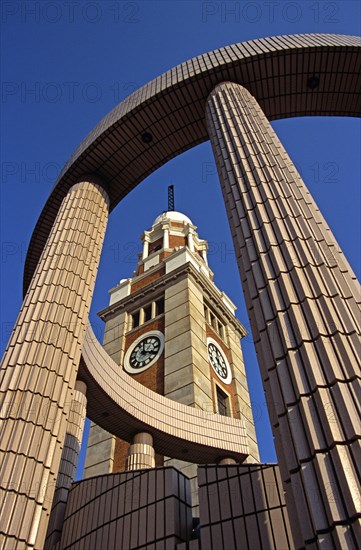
[84,211,259,506]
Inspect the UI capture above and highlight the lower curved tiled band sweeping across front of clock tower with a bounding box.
[78,326,248,464]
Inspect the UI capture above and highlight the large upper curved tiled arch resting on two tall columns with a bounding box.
[24,34,361,292]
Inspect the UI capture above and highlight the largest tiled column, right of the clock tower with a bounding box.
[207,82,360,548]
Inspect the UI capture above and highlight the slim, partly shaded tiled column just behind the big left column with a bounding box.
[45,381,87,550]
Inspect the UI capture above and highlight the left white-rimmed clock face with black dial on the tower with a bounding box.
[124,330,164,374]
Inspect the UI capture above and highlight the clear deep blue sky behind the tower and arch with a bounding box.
[0,0,360,474]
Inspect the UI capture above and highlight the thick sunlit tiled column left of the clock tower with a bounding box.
[0,178,108,549]
